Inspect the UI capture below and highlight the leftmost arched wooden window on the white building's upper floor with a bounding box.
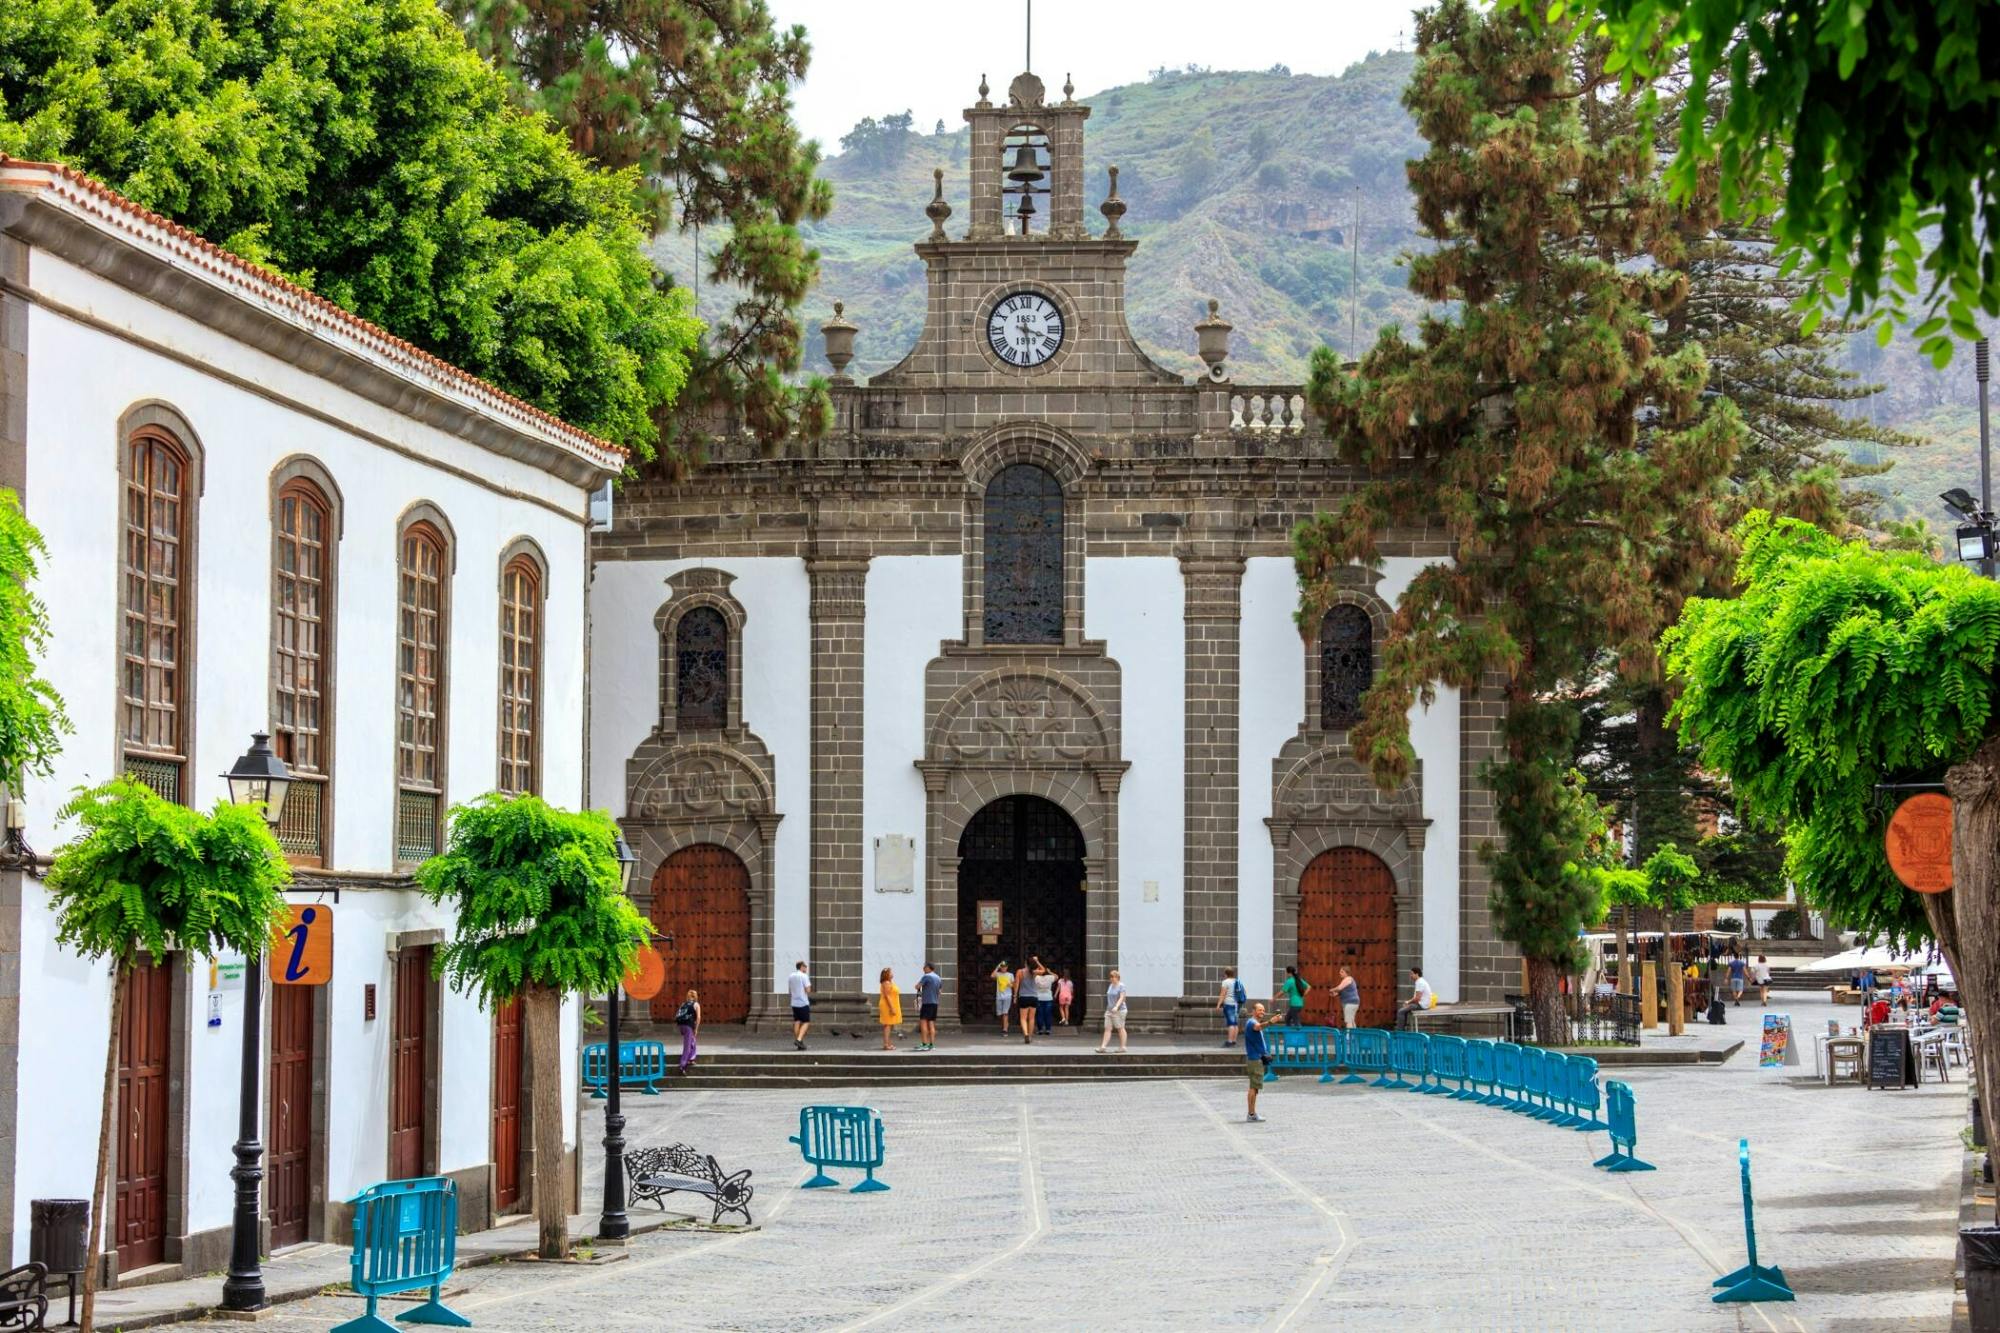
[118,424,194,801]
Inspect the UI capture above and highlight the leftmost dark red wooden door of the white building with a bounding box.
[116,963,174,1273]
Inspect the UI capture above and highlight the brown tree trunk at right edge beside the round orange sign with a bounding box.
[1924,739,2000,1216]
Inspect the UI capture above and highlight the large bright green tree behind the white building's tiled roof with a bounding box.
[0,0,700,454]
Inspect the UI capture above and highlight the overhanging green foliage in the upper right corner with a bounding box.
[1506,0,2000,366]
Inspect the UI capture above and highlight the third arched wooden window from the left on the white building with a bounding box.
[396,518,450,863]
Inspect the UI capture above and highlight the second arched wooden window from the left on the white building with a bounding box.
[270,476,336,865]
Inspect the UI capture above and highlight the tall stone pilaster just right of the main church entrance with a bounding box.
[1180,554,1244,1025]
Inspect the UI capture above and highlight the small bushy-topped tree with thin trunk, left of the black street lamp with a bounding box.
[48,777,292,1329]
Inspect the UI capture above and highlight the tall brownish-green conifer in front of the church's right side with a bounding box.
[1294,0,1738,1031]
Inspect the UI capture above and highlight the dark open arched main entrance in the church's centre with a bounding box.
[958,797,1090,1025]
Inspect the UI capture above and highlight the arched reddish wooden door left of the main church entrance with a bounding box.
[652,845,750,1023]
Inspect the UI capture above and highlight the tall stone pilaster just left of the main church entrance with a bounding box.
[804,556,868,1019]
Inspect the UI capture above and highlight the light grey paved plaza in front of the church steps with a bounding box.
[168,1003,1964,1331]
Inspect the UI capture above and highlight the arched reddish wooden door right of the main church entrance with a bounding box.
[1298,847,1396,1027]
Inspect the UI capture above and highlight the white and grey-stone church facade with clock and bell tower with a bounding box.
[590,74,1516,1029]
